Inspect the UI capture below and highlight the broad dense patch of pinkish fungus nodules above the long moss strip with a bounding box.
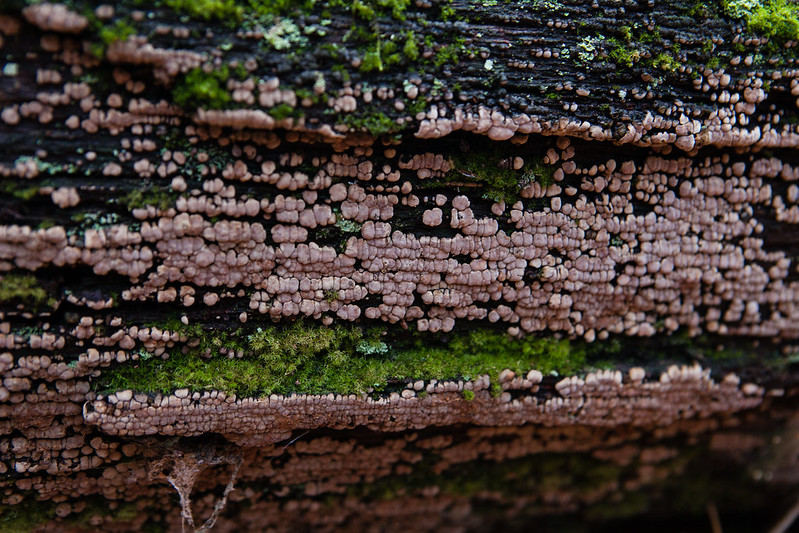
[0,138,799,340]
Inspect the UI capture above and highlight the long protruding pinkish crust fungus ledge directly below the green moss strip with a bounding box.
[83,366,764,445]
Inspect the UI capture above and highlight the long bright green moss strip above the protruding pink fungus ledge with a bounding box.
[97,321,586,396]
